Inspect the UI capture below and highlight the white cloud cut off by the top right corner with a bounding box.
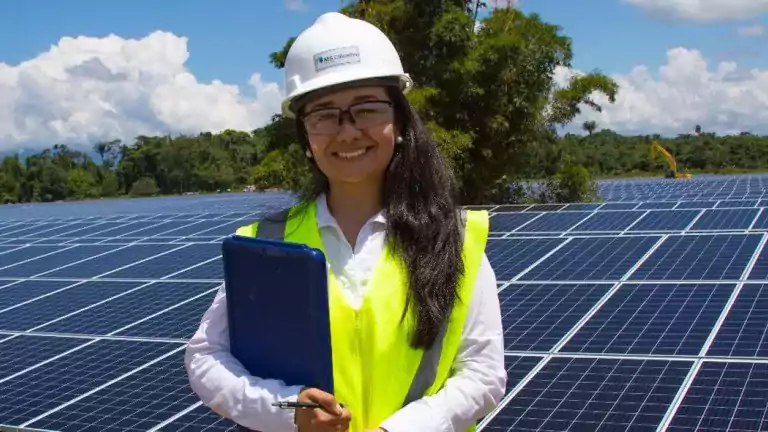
[623,0,768,22]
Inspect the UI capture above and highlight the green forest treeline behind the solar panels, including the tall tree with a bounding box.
[0,0,768,204]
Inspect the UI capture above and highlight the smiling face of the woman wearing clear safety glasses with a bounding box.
[302,87,396,189]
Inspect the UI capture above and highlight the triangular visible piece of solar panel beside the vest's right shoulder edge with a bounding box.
[485,238,565,281]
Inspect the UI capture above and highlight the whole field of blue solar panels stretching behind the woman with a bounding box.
[0,176,768,431]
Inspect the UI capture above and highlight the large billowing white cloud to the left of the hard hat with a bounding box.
[0,32,281,150]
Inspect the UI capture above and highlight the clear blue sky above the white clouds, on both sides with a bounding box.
[0,0,768,90]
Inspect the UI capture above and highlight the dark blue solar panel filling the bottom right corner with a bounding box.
[667,361,768,432]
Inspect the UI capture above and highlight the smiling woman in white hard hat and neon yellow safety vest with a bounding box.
[186,13,506,432]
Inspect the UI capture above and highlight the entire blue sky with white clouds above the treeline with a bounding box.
[0,0,768,152]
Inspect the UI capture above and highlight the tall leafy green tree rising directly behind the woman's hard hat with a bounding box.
[328,0,618,203]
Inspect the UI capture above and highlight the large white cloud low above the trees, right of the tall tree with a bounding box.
[556,47,768,135]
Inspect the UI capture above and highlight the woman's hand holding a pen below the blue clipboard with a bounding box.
[294,388,352,432]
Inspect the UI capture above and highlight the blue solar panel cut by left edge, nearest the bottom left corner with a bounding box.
[0,340,183,425]
